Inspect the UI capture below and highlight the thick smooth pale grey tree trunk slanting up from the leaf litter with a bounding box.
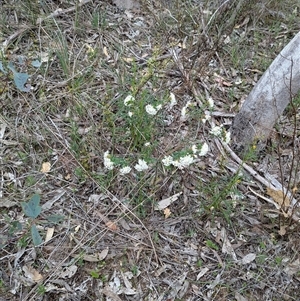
[231,32,300,152]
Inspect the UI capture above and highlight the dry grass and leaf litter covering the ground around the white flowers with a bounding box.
[0,0,300,301]
